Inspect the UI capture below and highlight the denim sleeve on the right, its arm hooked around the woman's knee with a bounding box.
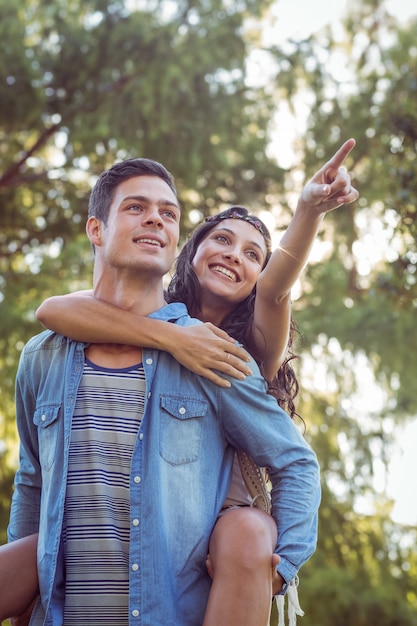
[218,361,321,582]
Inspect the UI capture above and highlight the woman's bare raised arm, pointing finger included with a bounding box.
[252,139,359,379]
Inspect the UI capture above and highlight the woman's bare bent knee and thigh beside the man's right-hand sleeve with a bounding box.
[203,507,278,626]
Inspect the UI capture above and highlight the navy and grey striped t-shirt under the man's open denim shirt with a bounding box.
[63,359,145,626]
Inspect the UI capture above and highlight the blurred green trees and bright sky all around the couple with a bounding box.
[0,0,417,626]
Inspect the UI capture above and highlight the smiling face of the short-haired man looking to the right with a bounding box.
[96,176,180,276]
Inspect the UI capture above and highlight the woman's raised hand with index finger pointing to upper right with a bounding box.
[300,139,359,213]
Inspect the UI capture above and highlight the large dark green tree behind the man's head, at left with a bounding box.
[0,0,281,540]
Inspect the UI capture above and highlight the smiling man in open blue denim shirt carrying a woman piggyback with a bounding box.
[9,159,320,626]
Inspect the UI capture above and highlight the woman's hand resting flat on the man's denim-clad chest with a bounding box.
[167,322,252,387]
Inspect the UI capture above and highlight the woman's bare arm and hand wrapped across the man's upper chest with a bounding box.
[36,291,251,387]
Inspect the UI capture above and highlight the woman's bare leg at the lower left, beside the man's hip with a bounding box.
[0,535,39,622]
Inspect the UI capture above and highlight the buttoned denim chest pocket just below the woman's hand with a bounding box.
[159,395,207,465]
